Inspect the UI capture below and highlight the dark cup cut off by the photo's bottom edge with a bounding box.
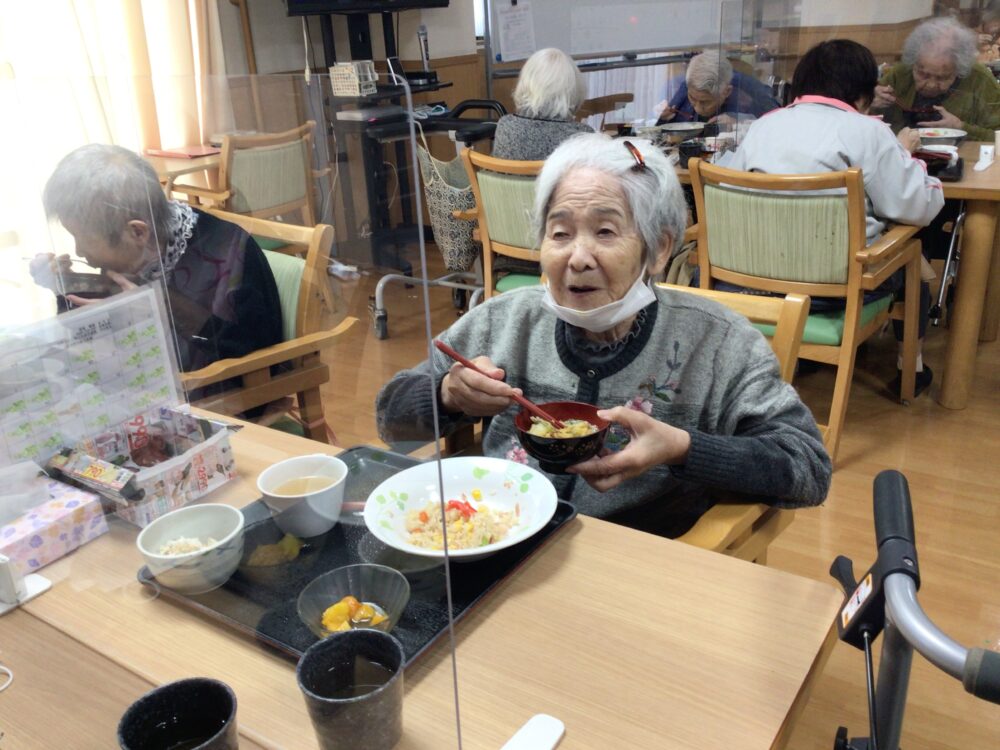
[118,677,239,750]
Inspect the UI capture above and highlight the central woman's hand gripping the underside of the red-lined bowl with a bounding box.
[567,406,691,492]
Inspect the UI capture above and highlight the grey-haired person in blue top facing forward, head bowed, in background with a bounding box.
[659,50,781,123]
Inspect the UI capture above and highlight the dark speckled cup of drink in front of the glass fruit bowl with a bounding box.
[295,630,406,750]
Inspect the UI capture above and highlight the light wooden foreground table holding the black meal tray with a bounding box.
[0,425,842,750]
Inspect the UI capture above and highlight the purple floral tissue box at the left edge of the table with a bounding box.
[0,480,108,575]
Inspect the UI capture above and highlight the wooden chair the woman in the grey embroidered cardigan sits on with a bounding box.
[658,284,809,565]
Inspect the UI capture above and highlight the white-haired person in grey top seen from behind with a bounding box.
[493,47,593,161]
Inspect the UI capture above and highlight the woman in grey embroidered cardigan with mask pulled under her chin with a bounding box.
[377,134,831,536]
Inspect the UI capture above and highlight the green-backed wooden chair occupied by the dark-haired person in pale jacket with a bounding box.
[689,159,920,460]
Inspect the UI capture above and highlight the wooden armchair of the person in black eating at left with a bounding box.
[181,211,357,442]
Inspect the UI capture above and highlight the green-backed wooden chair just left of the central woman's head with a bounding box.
[461,148,545,298]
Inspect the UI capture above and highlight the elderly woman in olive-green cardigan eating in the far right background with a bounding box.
[871,18,1000,137]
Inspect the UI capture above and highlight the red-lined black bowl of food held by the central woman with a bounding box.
[514,401,611,474]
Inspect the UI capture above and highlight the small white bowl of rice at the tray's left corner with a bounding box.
[135,503,244,594]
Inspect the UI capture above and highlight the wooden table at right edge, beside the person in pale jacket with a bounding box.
[677,141,1000,409]
